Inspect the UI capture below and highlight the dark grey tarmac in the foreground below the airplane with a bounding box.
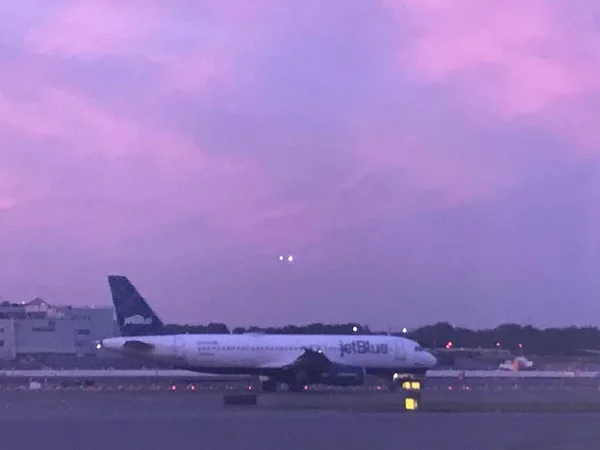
[0,391,600,450]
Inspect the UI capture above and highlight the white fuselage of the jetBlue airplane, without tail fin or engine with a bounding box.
[100,334,436,374]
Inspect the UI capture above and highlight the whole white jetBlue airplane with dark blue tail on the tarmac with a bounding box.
[97,275,437,392]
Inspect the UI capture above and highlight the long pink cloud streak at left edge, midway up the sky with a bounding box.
[0,82,276,248]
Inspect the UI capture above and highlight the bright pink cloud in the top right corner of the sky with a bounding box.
[387,0,600,148]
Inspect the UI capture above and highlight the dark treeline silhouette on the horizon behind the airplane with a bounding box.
[166,322,600,356]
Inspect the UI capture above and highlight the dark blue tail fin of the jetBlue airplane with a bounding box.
[108,275,164,336]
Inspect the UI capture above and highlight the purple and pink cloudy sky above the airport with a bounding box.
[0,0,600,328]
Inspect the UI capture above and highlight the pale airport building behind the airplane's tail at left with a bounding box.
[0,298,117,361]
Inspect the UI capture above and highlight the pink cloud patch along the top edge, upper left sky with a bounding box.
[25,1,248,99]
